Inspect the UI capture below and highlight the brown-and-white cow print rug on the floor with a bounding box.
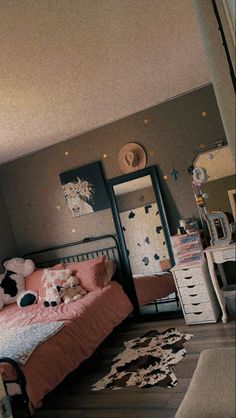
[91,328,193,390]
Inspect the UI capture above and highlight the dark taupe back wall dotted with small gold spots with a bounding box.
[0,85,225,253]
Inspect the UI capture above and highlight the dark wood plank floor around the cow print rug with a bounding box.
[14,318,235,418]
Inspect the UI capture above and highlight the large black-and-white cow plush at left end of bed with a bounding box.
[0,257,38,309]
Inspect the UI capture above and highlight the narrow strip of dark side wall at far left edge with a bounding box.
[0,187,18,273]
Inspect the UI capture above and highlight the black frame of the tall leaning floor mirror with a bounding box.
[106,166,174,314]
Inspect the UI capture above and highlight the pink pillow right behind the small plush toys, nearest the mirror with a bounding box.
[65,255,106,292]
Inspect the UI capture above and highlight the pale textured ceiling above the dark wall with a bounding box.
[0,0,210,167]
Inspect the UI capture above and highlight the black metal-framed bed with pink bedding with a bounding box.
[0,235,133,414]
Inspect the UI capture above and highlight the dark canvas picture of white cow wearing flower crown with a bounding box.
[59,161,110,218]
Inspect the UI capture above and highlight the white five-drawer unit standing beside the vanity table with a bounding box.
[172,260,220,325]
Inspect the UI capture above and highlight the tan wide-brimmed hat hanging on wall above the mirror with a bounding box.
[118,142,147,173]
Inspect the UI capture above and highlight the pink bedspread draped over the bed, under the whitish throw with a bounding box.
[0,282,133,410]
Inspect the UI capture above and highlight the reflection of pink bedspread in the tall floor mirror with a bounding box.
[134,273,176,306]
